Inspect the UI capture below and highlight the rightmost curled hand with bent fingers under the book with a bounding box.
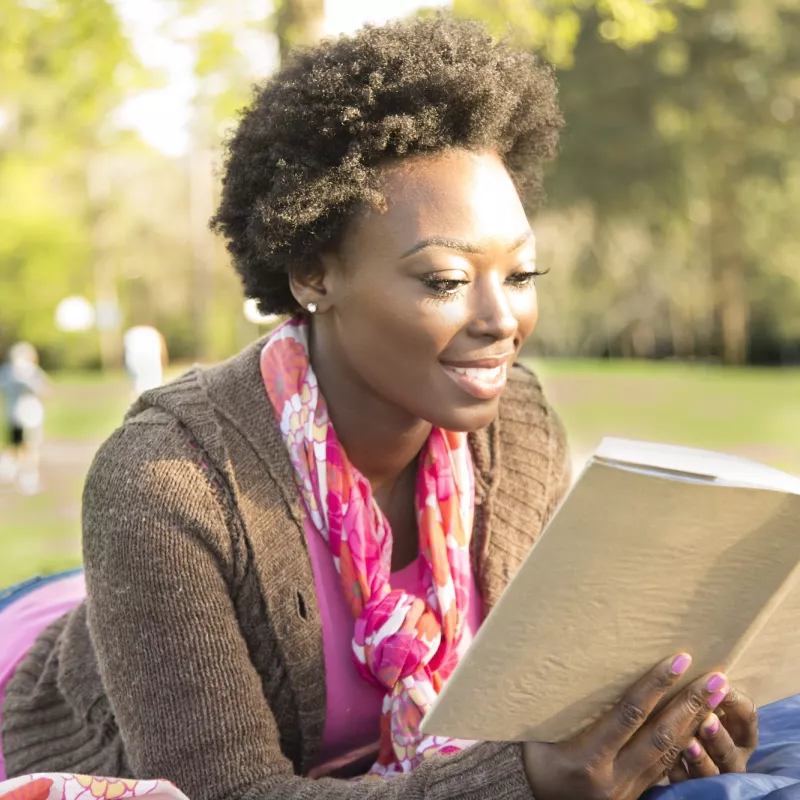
[669,688,758,783]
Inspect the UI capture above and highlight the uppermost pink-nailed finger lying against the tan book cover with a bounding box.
[582,653,692,755]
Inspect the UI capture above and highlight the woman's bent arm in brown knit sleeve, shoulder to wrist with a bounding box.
[84,415,531,800]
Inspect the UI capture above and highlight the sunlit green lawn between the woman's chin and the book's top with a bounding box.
[532,361,800,474]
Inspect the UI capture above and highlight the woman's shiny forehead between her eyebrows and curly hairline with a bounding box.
[346,151,528,250]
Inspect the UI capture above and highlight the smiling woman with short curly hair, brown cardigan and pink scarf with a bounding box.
[3,18,756,800]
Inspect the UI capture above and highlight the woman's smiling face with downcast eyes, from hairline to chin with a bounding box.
[310,151,537,431]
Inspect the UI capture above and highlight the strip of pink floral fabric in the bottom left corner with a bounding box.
[0,772,187,800]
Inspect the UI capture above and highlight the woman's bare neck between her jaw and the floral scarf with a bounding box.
[310,326,431,494]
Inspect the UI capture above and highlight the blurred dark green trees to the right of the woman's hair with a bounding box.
[528,0,800,363]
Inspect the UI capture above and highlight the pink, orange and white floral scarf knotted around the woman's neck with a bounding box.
[261,319,474,777]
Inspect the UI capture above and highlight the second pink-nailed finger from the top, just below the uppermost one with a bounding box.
[618,672,728,785]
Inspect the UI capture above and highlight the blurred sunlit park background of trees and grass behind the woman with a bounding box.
[0,0,800,587]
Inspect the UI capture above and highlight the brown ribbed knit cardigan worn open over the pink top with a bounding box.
[2,341,569,800]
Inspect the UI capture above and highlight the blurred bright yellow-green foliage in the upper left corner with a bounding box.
[0,0,142,368]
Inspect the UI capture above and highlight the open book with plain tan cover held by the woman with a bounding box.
[422,439,800,741]
